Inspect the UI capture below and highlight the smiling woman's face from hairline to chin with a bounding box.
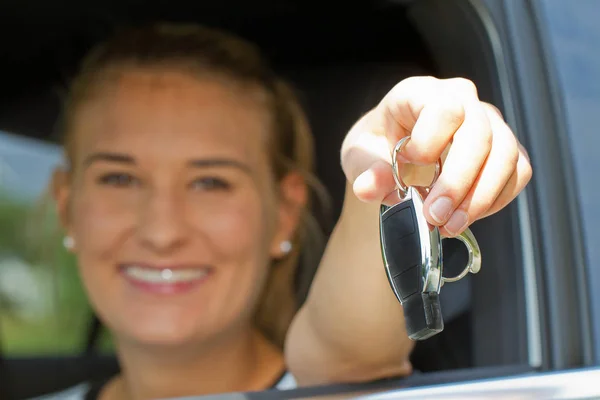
[57,70,302,344]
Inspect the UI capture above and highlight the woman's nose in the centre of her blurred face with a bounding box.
[137,190,187,254]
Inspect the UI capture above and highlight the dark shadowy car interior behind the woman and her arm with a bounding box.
[0,0,528,399]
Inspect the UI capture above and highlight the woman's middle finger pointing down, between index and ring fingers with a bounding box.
[424,101,493,226]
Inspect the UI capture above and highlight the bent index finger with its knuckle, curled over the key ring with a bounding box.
[381,78,468,165]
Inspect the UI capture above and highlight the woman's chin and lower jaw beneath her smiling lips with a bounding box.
[92,268,255,349]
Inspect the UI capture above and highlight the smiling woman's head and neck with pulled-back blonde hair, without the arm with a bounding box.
[44,26,328,398]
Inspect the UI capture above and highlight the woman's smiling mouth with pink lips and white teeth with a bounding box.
[119,264,211,294]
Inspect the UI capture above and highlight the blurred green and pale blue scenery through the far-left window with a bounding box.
[0,132,112,356]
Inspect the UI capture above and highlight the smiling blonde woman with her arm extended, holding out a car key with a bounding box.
[43,25,531,400]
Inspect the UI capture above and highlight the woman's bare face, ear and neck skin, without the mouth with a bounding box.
[52,71,305,399]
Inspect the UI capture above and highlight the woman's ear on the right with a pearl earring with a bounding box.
[271,172,308,259]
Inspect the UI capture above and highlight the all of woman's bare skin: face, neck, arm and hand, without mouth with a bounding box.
[55,71,531,399]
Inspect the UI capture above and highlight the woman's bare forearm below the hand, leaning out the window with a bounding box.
[286,179,413,384]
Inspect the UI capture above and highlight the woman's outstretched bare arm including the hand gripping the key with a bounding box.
[285,77,531,384]
